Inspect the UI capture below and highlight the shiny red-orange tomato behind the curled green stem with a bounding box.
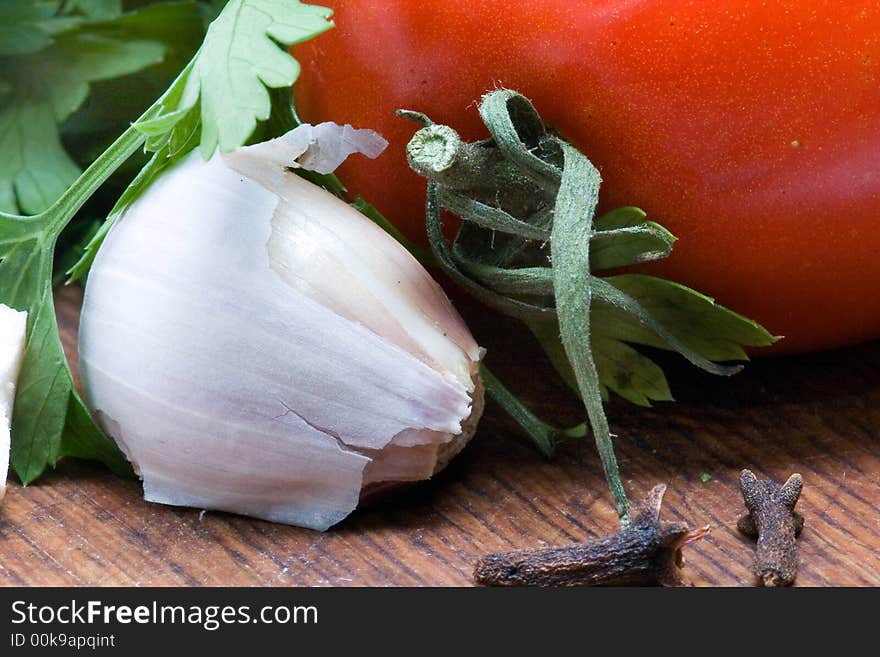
[294,0,880,352]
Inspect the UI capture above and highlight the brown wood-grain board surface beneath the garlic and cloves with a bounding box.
[0,289,880,586]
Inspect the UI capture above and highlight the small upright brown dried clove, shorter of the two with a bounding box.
[736,470,804,586]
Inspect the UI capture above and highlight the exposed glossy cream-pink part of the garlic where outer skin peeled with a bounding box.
[223,131,481,391]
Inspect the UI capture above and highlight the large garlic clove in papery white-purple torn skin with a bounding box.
[80,126,482,530]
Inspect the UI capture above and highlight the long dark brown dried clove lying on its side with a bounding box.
[474,484,709,586]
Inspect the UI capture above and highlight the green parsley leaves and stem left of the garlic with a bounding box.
[0,0,332,483]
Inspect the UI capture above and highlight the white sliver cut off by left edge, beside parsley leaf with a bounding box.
[0,304,27,500]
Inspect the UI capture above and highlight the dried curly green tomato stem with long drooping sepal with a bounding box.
[404,90,633,525]
